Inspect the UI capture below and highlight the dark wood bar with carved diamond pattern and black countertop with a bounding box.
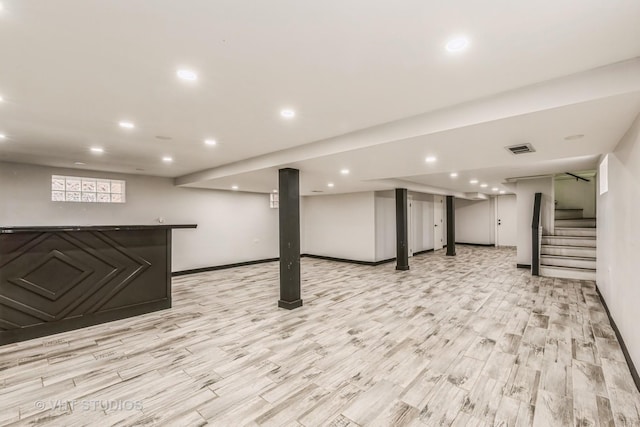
[0,224,196,345]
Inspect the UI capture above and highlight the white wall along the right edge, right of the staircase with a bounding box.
[596,116,640,374]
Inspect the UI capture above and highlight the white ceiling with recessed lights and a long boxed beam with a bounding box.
[0,0,640,194]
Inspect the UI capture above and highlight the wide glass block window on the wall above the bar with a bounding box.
[51,175,125,203]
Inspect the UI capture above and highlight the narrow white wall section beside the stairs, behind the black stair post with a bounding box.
[516,177,555,264]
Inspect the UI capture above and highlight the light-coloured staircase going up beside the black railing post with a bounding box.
[540,209,596,280]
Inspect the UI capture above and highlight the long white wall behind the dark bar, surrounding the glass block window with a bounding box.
[0,163,279,271]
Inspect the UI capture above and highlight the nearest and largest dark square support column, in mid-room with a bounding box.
[278,168,302,310]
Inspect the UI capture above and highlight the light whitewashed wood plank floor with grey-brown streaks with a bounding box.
[0,246,640,426]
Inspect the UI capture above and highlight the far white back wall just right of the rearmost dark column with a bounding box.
[456,199,495,245]
